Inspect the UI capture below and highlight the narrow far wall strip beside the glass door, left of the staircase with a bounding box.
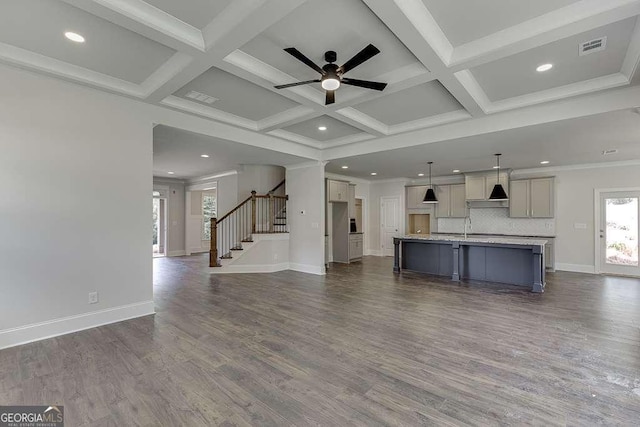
[153,177,185,256]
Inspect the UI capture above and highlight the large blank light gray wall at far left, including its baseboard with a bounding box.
[0,67,153,348]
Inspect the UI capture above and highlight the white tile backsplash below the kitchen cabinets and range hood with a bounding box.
[438,208,556,237]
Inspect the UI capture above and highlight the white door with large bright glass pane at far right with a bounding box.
[599,192,640,276]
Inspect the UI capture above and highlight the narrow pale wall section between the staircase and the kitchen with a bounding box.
[286,162,325,274]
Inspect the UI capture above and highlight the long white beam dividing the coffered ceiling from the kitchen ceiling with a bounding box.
[322,86,640,160]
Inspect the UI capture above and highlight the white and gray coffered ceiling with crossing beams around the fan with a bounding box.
[5,0,640,176]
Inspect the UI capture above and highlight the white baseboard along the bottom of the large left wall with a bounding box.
[0,301,155,350]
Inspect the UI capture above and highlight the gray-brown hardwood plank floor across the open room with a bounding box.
[0,256,640,426]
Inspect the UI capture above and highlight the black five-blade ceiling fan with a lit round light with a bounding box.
[274,44,387,105]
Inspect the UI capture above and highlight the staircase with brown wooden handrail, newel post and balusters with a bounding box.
[209,181,289,267]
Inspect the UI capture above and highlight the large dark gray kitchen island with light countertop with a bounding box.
[393,236,546,292]
